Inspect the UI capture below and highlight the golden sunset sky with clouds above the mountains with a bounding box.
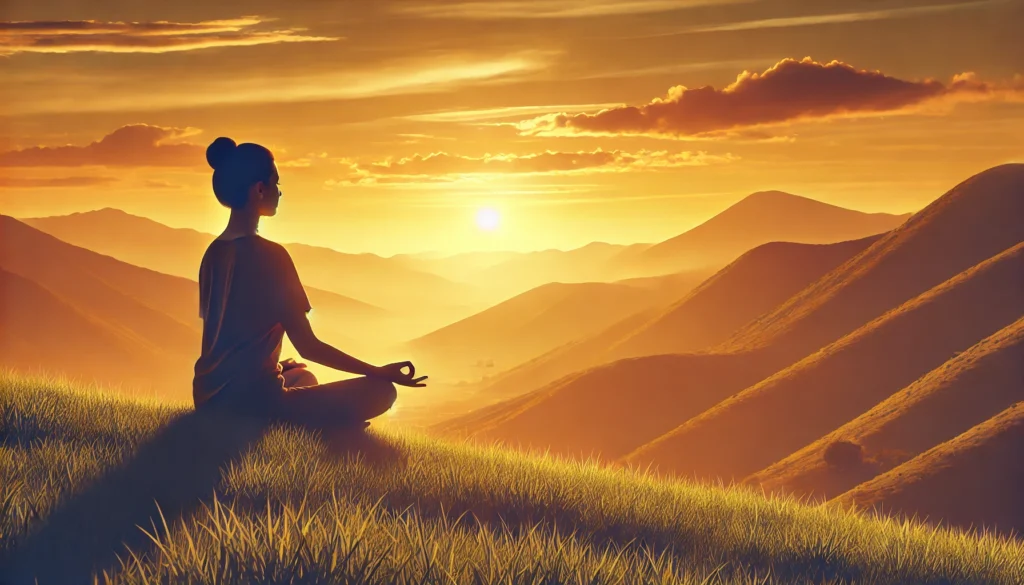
[0,0,1024,255]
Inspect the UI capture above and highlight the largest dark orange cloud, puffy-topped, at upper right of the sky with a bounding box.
[517,57,1021,137]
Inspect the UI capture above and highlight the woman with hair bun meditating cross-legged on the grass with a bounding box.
[193,136,426,425]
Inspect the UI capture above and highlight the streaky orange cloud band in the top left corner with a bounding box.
[0,16,340,55]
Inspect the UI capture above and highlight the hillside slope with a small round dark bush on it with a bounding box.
[745,318,1024,499]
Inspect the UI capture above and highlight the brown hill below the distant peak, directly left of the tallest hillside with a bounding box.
[611,236,881,358]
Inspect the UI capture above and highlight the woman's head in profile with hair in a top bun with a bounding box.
[206,136,281,215]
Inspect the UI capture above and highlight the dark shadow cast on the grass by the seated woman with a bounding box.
[0,411,399,585]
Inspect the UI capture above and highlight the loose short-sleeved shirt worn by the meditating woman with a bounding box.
[193,235,311,407]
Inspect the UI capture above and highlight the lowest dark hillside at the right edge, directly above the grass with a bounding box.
[837,402,1024,535]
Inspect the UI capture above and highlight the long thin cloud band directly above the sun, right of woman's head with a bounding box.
[327,149,735,186]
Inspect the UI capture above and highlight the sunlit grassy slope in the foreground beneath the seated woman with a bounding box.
[0,372,1024,585]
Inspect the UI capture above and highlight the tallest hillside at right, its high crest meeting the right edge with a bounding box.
[716,164,1024,362]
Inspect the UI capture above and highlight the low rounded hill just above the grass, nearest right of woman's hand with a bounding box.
[435,354,771,460]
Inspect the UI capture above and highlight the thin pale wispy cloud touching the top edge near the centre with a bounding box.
[391,0,755,20]
